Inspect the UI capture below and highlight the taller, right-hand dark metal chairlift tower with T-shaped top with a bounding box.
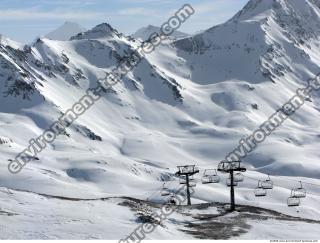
[218,161,246,211]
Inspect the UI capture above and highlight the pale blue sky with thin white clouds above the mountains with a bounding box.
[0,0,248,43]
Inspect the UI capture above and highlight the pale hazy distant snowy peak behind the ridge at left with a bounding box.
[45,21,86,41]
